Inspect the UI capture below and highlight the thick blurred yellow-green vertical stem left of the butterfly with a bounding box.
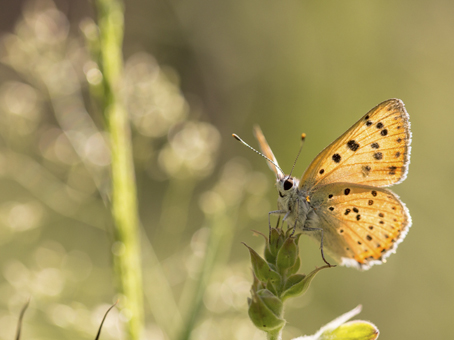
[96,0,143,340]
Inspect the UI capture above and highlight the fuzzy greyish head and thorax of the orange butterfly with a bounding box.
[276,176,317,230]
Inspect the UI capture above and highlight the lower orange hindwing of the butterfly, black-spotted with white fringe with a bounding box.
[303,183,411,269]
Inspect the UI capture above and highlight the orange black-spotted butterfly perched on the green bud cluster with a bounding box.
[234,99,411,270]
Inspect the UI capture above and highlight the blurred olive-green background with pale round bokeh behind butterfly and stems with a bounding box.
[0,0,454,340]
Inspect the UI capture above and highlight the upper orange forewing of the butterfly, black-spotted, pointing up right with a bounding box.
[299,99,411,191]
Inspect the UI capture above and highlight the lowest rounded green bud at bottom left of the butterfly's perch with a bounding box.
[249,289,285,332]
